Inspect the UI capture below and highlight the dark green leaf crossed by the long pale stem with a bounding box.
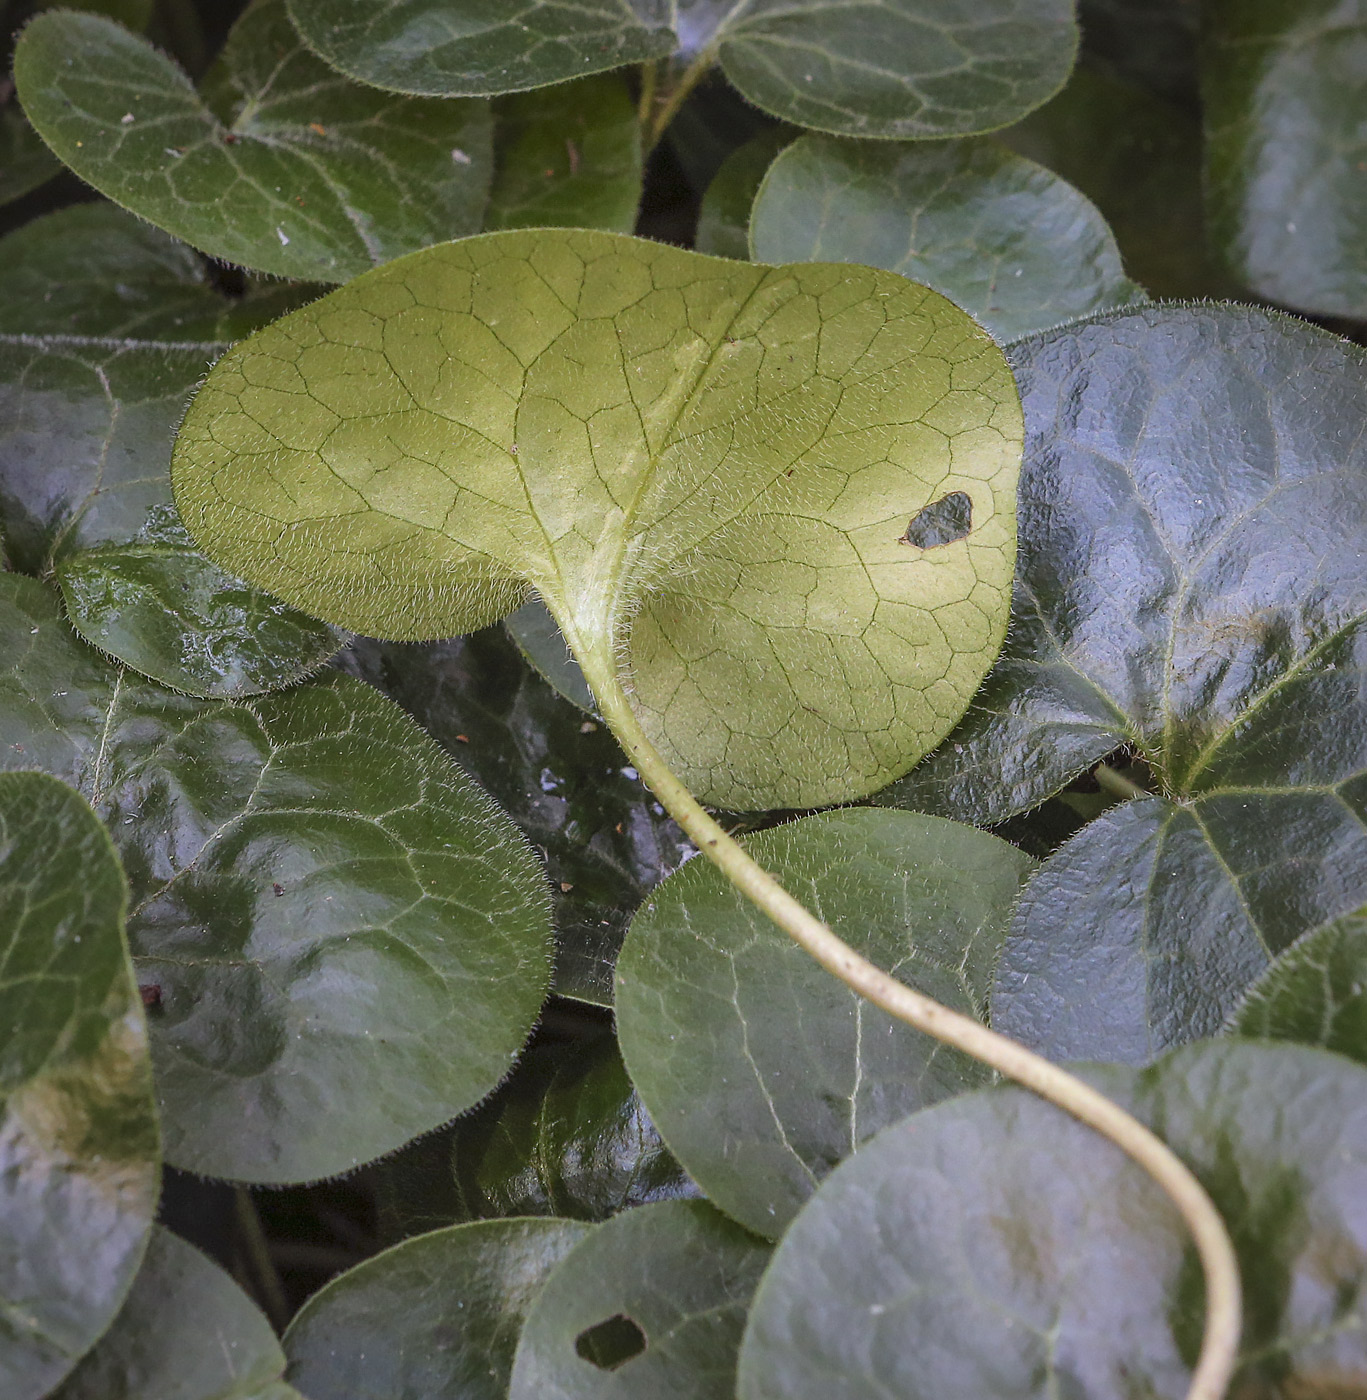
[616,808,1032,1236]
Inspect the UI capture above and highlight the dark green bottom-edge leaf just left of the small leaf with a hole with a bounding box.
[284,1219,590,1400]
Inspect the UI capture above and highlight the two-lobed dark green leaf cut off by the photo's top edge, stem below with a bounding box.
[290,0,1077,137]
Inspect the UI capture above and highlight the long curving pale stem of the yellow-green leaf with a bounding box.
[578,651,1242,1400]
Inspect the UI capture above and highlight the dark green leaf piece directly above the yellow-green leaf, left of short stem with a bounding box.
[485,74,641,234]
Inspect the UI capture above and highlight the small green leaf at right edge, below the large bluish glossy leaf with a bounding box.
[1230,910,1367,1063]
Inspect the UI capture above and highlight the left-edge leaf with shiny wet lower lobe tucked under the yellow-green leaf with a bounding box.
[0,336,339,696]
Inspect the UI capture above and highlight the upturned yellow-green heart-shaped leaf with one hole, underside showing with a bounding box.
[172,230,1020,809]
